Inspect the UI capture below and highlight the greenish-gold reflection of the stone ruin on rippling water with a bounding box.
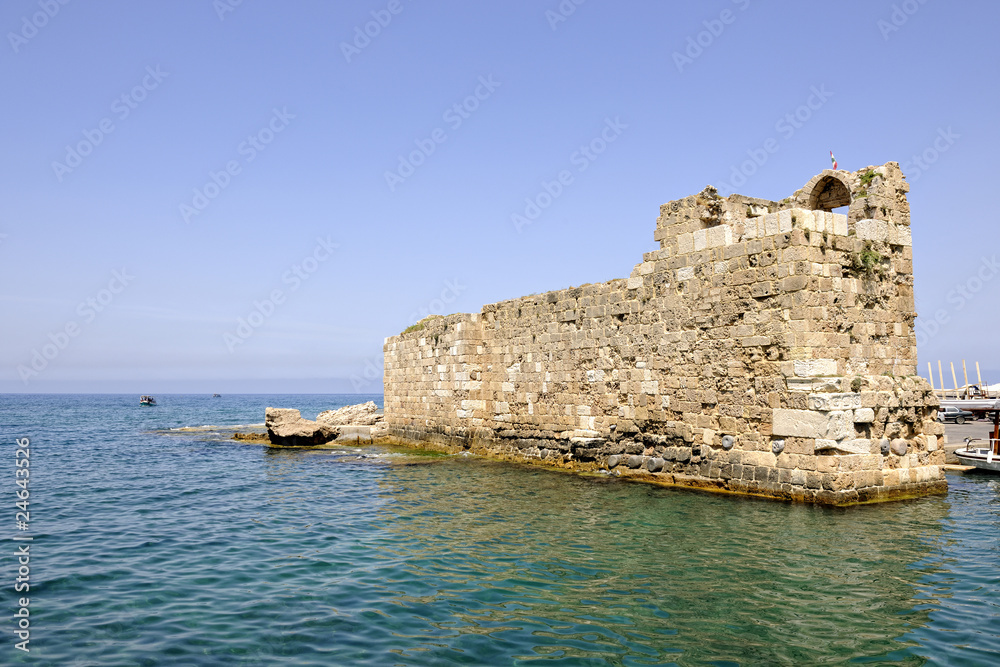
[372,461,949,664]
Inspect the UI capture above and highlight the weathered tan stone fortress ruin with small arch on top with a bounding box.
[384,162,947,505]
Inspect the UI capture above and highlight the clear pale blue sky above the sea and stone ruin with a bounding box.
[0,0,1000,393]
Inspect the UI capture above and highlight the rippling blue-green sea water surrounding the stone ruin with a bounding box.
[0,395,1000,665]
